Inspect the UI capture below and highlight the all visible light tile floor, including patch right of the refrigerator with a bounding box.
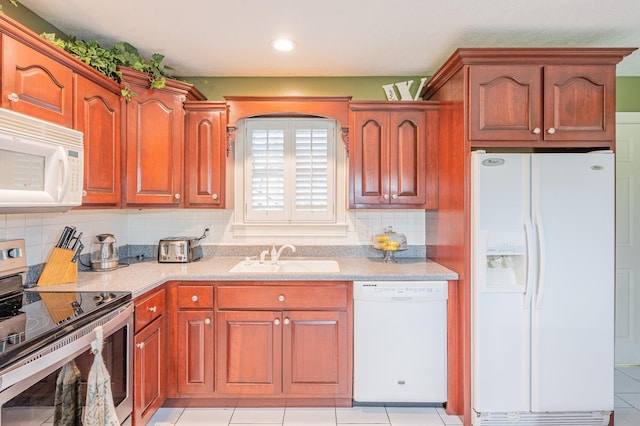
[142,366,640,426]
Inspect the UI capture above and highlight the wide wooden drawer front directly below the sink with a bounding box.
[218,285,348,310]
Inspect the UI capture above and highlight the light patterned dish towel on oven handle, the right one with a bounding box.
[84,326,120,426]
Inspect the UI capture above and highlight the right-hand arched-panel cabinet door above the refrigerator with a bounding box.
[544,65,615,141]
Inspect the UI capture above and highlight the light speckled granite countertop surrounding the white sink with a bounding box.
[32,256,458,298]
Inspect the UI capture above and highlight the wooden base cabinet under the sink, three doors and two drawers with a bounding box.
[166,281,353,406]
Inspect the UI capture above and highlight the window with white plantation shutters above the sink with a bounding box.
[244,118,336,223]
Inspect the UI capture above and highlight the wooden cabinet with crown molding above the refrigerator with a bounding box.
[421,48,635,149]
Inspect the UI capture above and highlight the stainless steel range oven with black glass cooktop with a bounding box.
[0,242,134,426]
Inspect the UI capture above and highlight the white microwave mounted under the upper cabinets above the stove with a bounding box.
[0,108,84,213]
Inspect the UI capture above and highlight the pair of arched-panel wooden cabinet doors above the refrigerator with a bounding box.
[469,64,615,144]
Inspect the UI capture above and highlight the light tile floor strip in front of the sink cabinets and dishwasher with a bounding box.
[149,407,462,426]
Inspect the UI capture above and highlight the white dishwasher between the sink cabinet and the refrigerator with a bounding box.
[353,281,448,405]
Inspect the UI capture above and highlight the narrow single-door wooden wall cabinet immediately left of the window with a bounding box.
[185,103,227,208]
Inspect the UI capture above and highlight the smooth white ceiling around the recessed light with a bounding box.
[15,0,640,77]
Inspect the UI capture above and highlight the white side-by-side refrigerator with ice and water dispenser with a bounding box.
[471,151,615,426]
